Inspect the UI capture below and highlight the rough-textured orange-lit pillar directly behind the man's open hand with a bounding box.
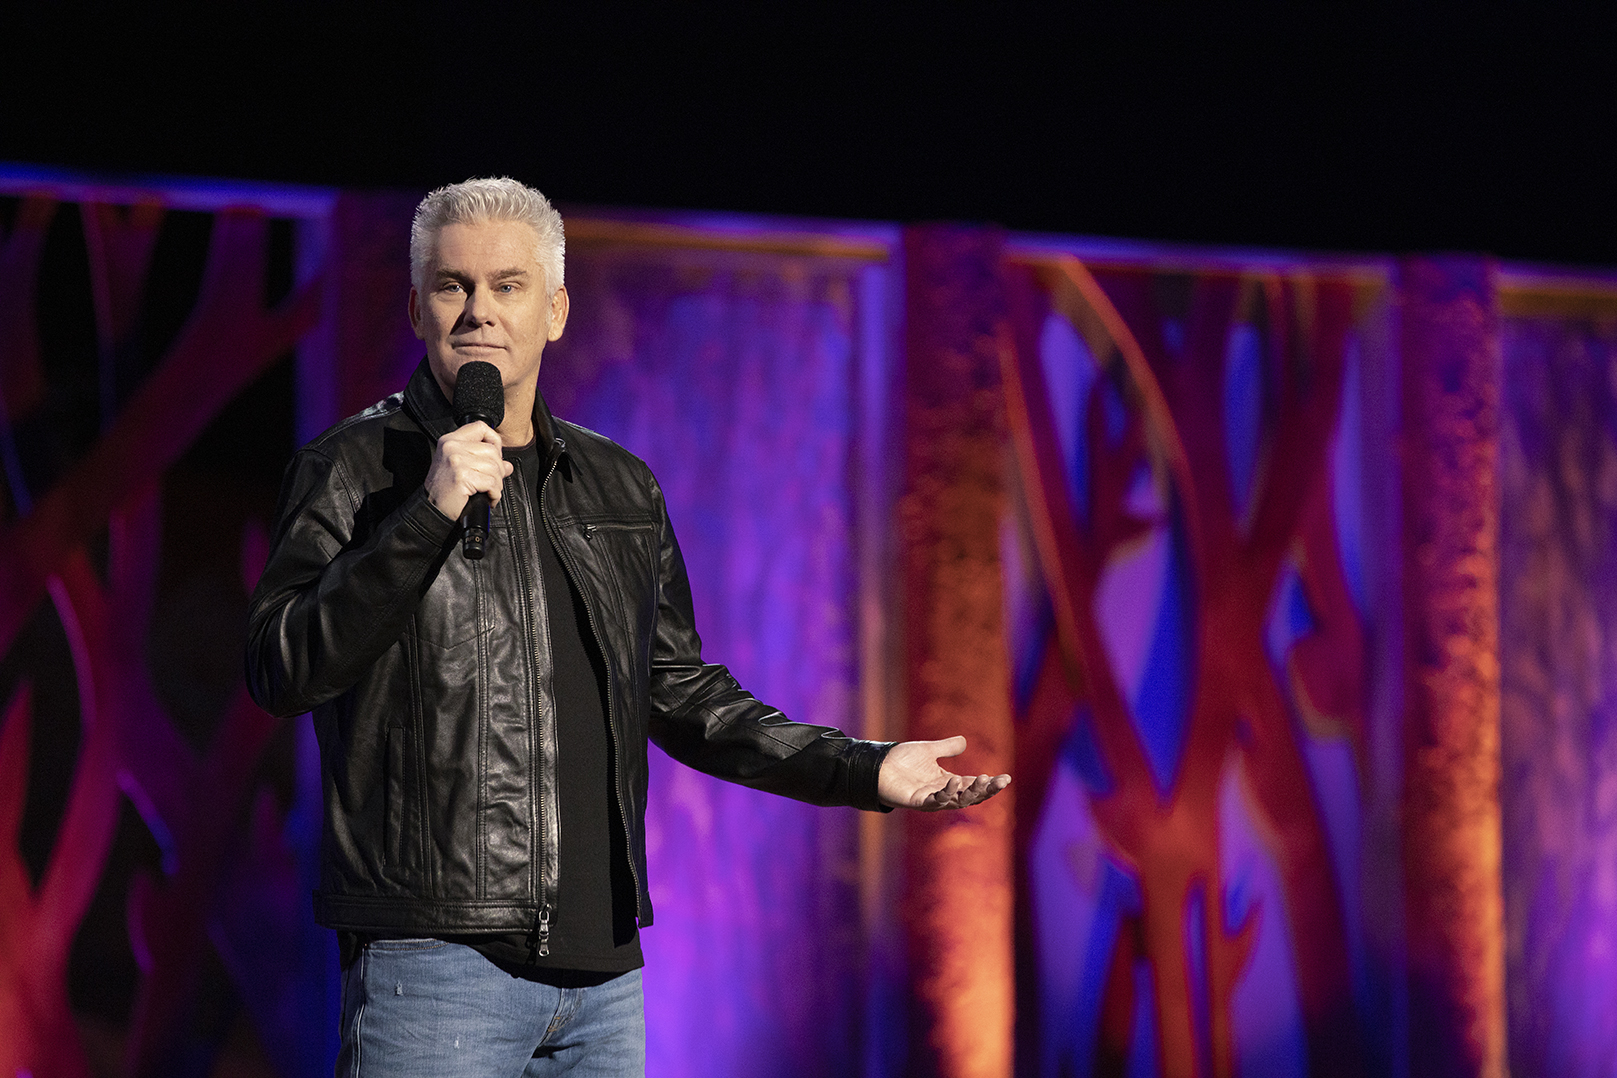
[899,226,1014,1078]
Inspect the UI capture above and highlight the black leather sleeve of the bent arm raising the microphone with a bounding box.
[247,448,454,716]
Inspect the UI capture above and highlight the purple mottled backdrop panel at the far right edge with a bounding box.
[1501,305,1617,1078]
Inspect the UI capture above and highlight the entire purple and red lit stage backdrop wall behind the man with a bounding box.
[0,166,1617,1078]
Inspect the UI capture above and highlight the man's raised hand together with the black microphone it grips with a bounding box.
[425,360,511,559]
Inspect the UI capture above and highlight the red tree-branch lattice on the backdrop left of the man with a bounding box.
[0,196,320,1076]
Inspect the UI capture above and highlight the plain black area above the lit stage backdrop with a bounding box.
[0,0,1617,265]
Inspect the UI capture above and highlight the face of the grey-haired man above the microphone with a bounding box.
[409,221,568,399]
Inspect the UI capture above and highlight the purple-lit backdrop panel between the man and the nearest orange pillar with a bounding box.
[540,247,886,1075]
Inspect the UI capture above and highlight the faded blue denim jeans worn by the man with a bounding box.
[336,939,645,1078]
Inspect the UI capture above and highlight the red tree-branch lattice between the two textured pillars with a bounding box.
[1003,257,1365,1075]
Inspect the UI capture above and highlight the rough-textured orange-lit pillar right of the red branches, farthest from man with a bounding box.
[1399,257,1505,1078]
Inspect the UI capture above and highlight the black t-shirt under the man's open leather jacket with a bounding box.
[461,443,645,979]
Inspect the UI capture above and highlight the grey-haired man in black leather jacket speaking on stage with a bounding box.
[247,179,1011,1078]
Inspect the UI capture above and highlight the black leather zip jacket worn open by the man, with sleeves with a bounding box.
[247,362,888,936]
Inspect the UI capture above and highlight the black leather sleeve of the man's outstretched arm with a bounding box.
[650,480,893,811]
